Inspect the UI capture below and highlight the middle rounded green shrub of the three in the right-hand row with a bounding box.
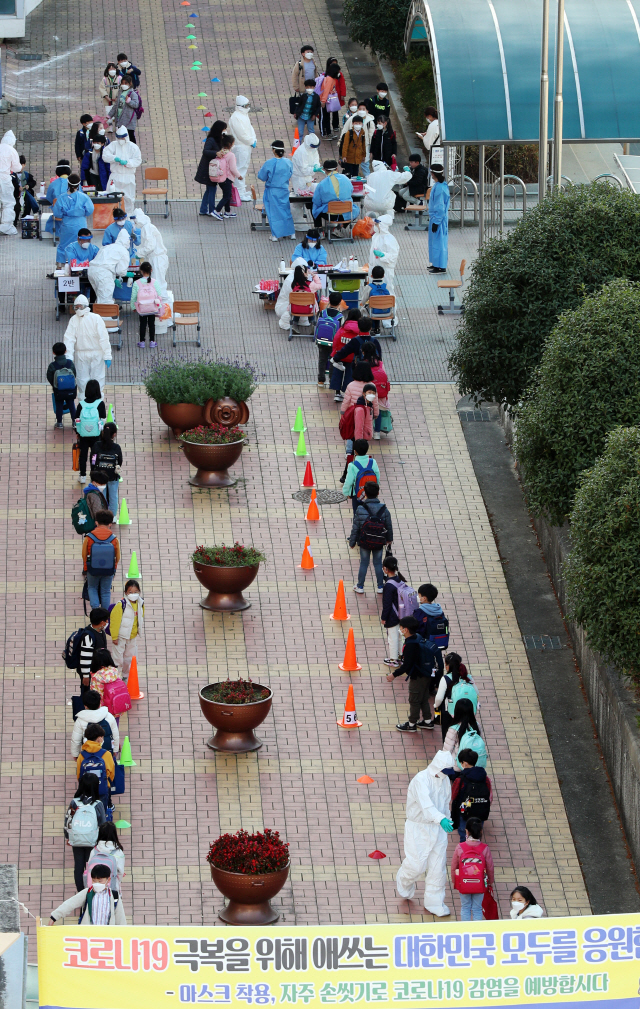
[516,281,640,525]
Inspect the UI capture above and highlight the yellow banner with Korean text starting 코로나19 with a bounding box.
[37,914,640,1009]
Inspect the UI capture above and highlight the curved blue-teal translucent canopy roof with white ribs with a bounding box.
[405,0,640,143]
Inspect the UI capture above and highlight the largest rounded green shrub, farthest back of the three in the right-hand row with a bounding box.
[449,183,640,408]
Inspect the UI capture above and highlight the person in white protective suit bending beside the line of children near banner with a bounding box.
[396,750,453,918]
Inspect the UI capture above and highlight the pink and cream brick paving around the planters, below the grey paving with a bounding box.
[0,385,589,944]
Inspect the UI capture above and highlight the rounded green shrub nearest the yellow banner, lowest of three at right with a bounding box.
[564,427,640,682]
